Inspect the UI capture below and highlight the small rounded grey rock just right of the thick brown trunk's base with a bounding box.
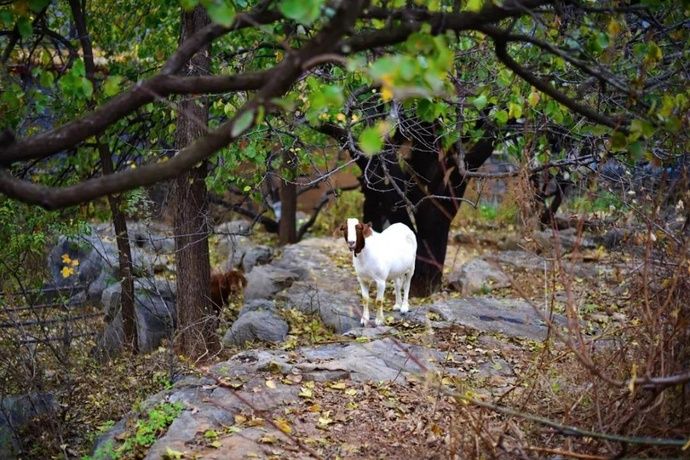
[223,311,289,346]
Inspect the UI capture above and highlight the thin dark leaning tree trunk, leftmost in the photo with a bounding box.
[69,0,138,352]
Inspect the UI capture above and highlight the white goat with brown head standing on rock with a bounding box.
[340,218,417,326]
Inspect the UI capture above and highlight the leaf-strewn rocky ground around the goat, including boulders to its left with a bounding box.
[90,222,625,459]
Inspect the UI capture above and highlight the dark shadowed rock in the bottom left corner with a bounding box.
[0,393,59,459]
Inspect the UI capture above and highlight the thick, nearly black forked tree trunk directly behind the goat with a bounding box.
[357,121,495,297]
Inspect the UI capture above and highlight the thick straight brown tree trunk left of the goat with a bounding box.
[172,6,218,358]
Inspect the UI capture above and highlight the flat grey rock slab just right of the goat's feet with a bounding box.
[409,297,566,340]
